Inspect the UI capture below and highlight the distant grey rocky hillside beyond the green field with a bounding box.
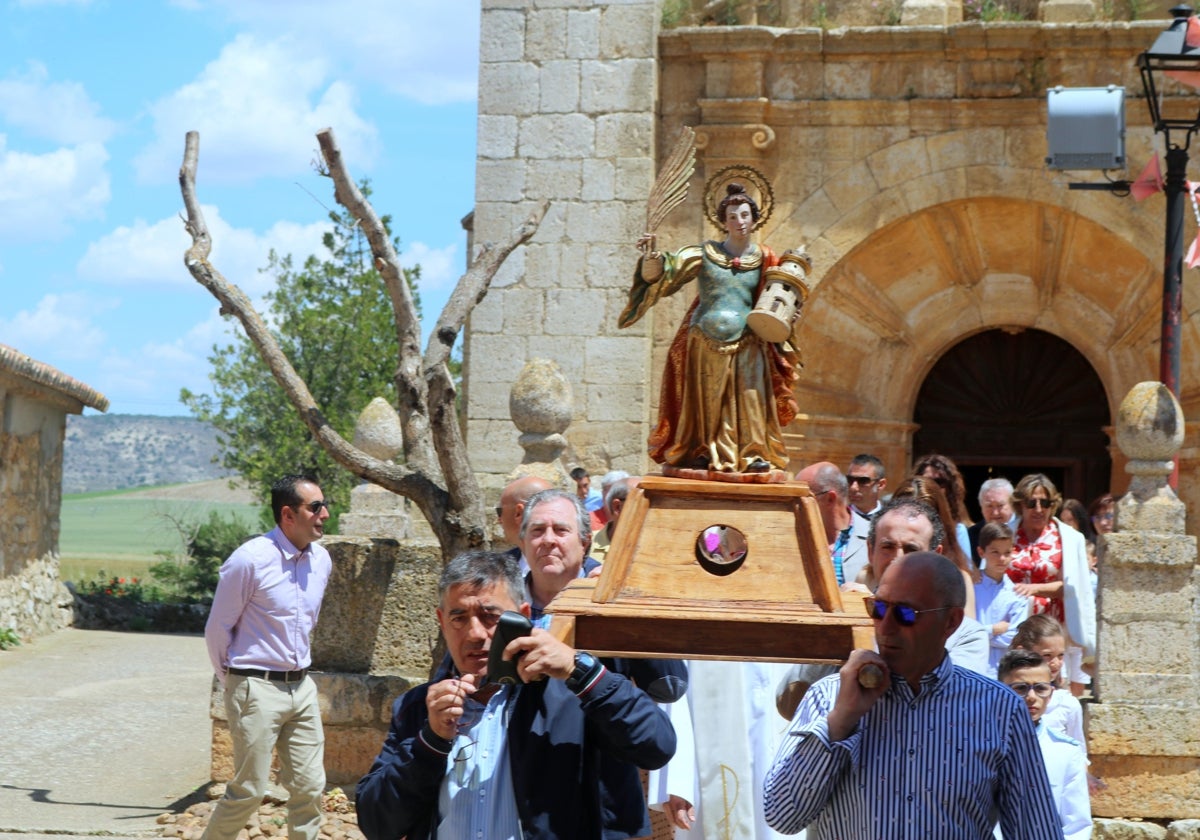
[62,414,229,493]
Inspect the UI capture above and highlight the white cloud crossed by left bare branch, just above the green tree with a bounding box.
[76,205,329,299]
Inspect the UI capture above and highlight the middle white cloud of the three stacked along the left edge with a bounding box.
[0,134,110,241]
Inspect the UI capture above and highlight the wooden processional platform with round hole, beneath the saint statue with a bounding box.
[547,476,874,664]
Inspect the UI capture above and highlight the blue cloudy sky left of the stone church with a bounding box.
[0,0,479,414]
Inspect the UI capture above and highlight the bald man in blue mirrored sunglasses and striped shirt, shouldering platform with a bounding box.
[763,552,1063,840]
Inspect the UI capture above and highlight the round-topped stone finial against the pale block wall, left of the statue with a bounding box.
[509,359,575,463]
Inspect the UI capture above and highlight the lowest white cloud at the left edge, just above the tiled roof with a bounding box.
[0,293,109,359]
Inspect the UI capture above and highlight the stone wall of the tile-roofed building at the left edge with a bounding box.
[0,386,71,637]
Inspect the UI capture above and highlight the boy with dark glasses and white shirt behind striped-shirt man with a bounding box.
[998,648,1092,840]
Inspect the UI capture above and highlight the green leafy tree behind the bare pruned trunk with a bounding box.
[180,189,420,533]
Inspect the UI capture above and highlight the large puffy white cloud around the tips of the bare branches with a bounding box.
[134,34,378,182]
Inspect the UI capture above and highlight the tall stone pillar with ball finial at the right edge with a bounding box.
[1088,382,1200,818]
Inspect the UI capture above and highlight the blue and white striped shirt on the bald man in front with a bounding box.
[764,656,1062,840]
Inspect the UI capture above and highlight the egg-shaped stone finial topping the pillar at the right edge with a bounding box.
[1116,382,1186,534]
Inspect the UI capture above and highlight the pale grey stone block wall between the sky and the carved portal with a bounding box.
[463,0,659,475]
